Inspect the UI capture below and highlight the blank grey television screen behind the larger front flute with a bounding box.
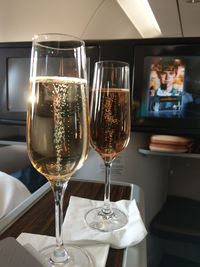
[0,42,99,125]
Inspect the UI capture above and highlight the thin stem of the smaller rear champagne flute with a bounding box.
[103,162,112,214]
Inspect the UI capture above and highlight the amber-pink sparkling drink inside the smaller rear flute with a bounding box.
[90,89,130,160]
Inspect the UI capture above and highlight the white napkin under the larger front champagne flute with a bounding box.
[17,233,109,267]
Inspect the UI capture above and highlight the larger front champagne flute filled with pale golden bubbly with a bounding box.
[27,34,92,267]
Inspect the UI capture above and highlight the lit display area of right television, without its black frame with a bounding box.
[141,57,200,118]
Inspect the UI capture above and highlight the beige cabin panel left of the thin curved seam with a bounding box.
[0,0,101,42]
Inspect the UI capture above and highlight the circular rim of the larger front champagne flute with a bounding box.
[32,32,85,50]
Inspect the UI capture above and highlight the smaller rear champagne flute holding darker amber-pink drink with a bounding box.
[85,61,130,232]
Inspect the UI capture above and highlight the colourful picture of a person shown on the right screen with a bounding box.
[148,58,185,112]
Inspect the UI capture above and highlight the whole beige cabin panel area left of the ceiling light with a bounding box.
[0,0,140,42]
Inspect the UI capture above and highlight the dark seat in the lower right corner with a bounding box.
[150,195,200,267]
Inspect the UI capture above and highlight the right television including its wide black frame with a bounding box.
[132,46,200,135]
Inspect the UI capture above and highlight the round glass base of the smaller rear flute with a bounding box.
[85,207,128,232]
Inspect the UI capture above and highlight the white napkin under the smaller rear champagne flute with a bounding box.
[63,196,147,249]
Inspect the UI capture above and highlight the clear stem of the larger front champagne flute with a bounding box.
[51,181,69,263]
